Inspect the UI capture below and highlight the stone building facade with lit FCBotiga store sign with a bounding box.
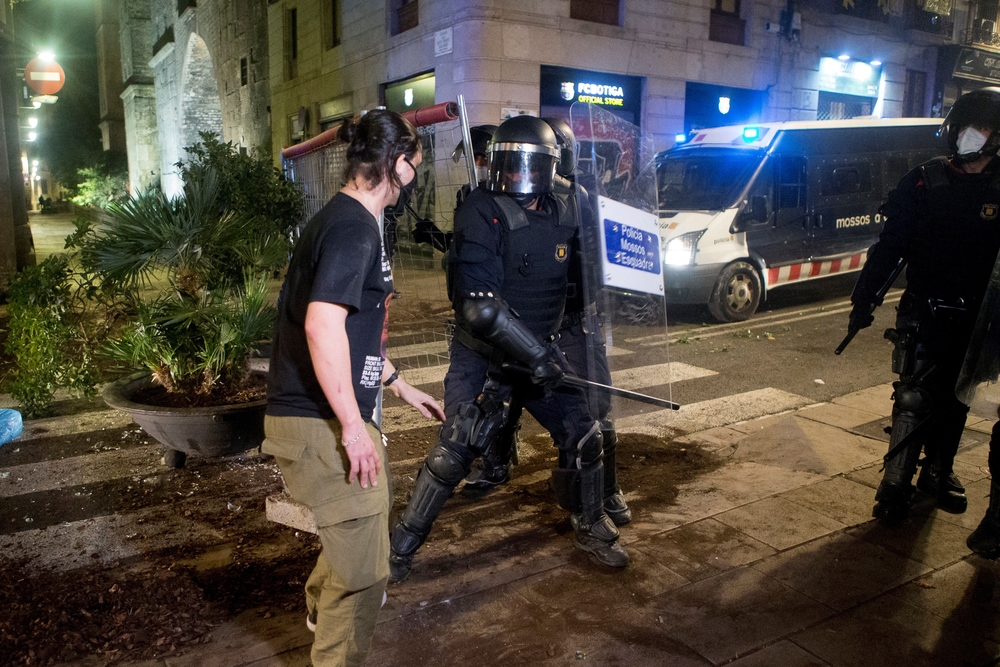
[268,0,972,155]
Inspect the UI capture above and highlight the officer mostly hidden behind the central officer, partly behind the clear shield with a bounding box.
[465,118,632,526]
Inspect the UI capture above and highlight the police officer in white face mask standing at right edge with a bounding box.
[850,88,1000,526]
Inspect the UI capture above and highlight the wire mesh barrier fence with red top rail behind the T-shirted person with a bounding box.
[281,103,469,384]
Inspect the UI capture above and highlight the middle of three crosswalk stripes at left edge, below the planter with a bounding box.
[0,445,163,498]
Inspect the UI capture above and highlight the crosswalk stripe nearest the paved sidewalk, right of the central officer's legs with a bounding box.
[615,387,813,437]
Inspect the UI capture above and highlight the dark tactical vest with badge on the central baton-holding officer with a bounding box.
[494,193,579,339]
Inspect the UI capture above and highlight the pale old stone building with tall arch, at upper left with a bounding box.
[119,0,271,196]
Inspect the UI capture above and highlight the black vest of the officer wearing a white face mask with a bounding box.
[906,158,1000,303]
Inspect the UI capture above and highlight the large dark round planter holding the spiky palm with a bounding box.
[103,371,267,468]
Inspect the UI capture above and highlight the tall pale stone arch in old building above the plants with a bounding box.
[180,33,223,162]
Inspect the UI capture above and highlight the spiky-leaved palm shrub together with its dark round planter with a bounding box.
[75,166,288,467]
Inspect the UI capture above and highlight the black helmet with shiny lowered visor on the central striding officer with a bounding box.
[486,116,559,205]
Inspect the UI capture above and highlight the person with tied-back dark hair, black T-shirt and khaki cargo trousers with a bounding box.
[262,109,444,667]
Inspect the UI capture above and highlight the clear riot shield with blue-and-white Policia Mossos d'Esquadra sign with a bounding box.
[570,104,673,434]
